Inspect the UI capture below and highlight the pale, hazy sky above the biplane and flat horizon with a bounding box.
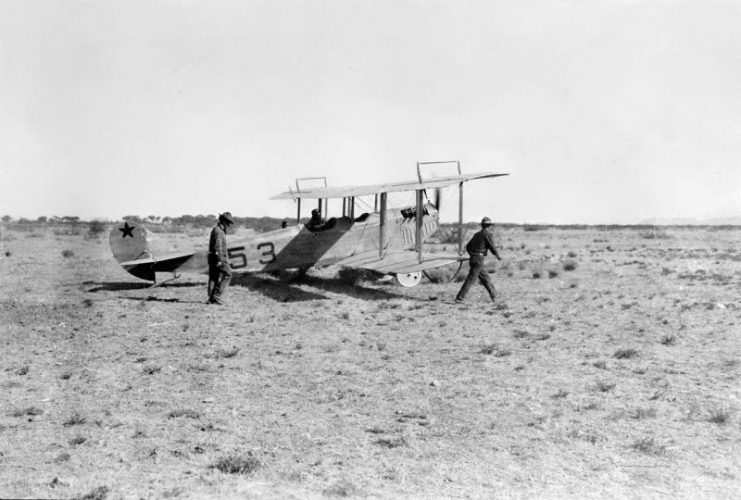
[0,0,741,223]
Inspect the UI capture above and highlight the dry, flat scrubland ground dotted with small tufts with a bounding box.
[0,227,741,498]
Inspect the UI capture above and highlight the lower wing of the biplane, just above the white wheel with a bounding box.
[337,250,468,274]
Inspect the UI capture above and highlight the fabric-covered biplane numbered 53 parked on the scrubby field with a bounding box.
[109,162,508,287]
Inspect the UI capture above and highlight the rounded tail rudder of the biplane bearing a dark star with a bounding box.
[109,222,155,281]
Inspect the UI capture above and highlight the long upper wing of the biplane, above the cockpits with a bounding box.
[270,172,509,200]
